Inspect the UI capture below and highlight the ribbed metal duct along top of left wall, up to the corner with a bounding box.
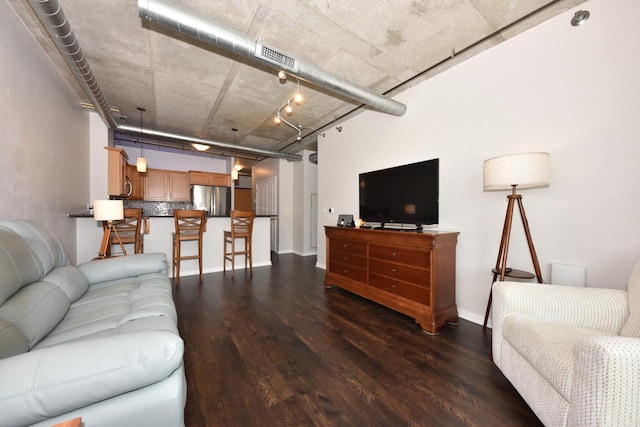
[29,0,118,130]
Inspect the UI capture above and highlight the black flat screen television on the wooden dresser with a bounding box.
[360,159,440,229]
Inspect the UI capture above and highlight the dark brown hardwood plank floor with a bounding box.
[174,254,541,427]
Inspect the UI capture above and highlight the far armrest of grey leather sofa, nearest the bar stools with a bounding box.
[78,253,168,285]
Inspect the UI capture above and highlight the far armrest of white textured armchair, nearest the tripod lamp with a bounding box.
[491,282,629,360]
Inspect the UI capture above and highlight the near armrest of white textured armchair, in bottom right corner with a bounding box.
[567,336,640,426]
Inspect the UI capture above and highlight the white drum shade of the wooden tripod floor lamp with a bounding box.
[483,152,550,191]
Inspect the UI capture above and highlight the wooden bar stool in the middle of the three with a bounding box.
[172,209,207,286]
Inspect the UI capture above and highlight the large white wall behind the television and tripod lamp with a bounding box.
[318,0,640,323]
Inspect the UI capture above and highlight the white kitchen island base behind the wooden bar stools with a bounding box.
[70,212,271,277]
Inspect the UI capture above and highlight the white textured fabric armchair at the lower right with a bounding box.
[492,263,640,427]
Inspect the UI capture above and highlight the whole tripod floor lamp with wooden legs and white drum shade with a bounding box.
[482,153,549,330]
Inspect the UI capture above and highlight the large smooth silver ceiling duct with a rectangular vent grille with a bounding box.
[138,0,407,116]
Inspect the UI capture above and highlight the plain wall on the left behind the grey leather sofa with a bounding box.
[0,2,90,261]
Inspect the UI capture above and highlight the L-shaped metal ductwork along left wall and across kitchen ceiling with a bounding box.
[24,0,302,161]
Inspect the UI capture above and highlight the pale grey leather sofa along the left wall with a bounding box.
[0,221,186,427]
